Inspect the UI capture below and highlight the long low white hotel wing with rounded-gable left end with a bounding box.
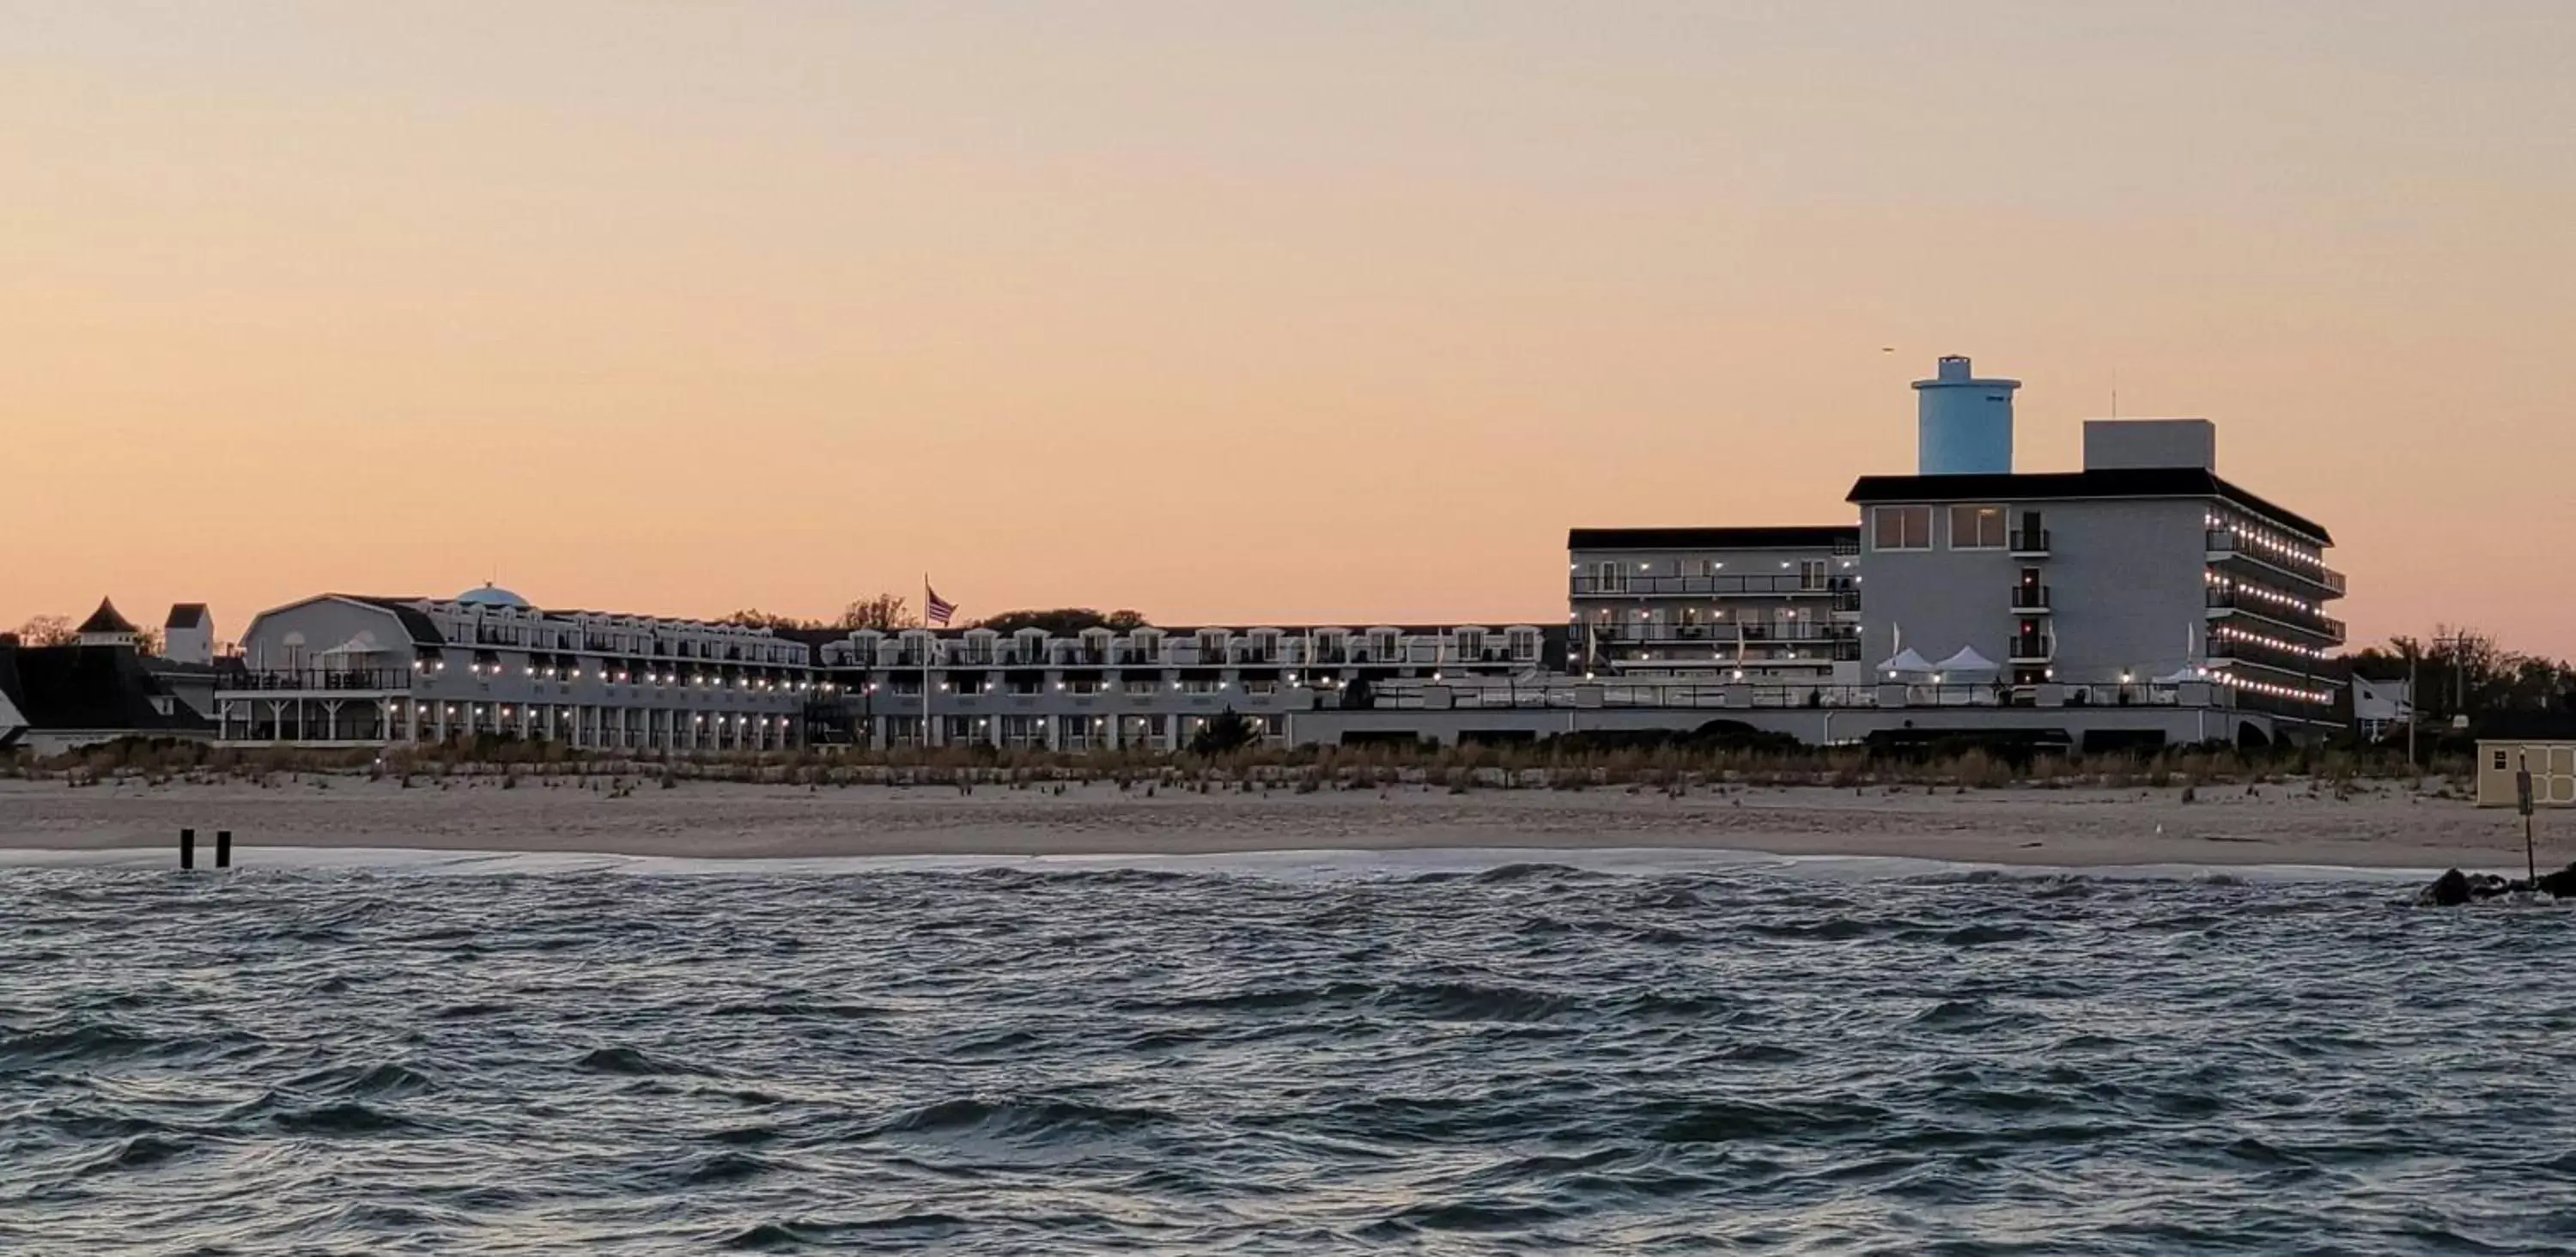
[214,587,1566,755]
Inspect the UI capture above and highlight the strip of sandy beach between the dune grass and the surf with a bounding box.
[0,778,2535,871]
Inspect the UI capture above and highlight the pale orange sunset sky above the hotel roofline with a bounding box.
[0,0,2576,654]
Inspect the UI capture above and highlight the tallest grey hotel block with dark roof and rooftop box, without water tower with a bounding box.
[1852,420,2344,724]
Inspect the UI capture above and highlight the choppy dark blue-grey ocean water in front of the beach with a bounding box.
[0,853,2576,1254]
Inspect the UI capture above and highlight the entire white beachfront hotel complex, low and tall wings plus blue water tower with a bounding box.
[216,358,2344,755]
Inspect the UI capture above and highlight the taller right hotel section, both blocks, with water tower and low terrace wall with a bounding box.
[1309,358,2344,747]
